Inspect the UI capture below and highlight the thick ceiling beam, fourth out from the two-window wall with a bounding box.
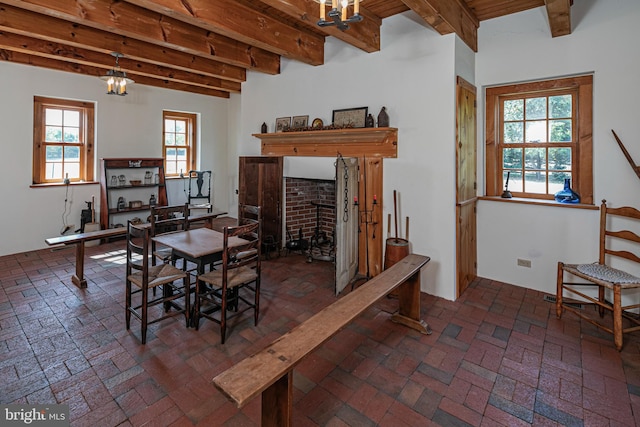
[2,0,280,74]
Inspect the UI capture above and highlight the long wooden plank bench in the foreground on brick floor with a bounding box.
[213,254,431,427]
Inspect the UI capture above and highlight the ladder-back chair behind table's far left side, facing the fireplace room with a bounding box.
[149,203,189,269]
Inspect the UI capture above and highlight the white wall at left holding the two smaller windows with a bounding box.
[0,61,229,255]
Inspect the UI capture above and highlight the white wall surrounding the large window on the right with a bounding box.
[476,0,640,293]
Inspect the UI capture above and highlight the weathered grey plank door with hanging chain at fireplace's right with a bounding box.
[335,157,358,295]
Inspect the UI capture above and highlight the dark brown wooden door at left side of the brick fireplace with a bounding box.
[238,156,283,249]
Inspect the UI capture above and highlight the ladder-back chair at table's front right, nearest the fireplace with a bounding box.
[193,222,260,344]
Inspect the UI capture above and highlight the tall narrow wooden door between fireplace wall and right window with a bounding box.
[456,77,477,297]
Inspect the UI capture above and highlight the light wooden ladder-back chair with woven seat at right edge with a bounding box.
[556,200,640,350]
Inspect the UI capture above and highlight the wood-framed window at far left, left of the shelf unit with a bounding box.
[33,96,95,184]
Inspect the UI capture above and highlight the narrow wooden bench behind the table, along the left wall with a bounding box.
[44,211,226,288]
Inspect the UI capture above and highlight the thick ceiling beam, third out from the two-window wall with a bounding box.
[0,5,246,82]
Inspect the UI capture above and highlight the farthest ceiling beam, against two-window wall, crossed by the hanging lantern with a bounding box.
[0,49,229,98]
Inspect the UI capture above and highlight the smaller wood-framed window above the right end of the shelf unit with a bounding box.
[162,111,196,177]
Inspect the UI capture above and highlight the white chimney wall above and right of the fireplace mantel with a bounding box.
[235,13,456,299]
